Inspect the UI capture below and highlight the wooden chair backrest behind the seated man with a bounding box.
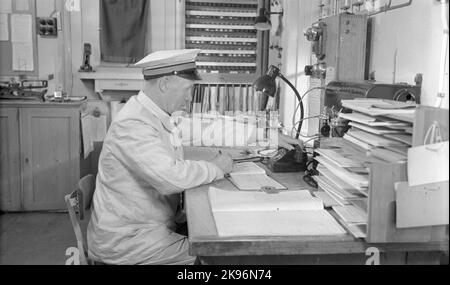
[65,174,95,265]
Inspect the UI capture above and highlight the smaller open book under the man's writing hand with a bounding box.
[229,162,286,190]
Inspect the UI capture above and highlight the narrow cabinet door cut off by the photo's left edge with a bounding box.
[0,107,21,211]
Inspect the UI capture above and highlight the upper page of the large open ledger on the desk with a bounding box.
[208,187,323,212]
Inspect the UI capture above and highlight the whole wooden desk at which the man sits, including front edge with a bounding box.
[185,150,448,265]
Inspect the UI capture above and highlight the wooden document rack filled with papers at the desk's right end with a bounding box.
[316,102,448,243]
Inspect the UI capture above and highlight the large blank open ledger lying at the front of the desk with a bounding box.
[208,187,346,237]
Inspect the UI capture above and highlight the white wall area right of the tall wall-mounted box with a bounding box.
[370,0,449,109]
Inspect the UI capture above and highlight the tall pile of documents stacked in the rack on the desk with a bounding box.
[315,99,415,238]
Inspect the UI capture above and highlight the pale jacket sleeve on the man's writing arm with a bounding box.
[108,118,224,195]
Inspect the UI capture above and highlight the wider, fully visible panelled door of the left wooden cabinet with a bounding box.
[20,108,80,211]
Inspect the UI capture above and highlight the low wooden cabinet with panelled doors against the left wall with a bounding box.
[0,104,80,211]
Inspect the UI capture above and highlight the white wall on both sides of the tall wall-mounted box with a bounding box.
[281,0,449,134]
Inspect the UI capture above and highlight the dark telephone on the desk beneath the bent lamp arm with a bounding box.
[265,145,308,173]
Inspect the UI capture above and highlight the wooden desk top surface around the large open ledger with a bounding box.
[185,146,448,256]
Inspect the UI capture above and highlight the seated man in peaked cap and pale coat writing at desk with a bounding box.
[87,50,297,265]
